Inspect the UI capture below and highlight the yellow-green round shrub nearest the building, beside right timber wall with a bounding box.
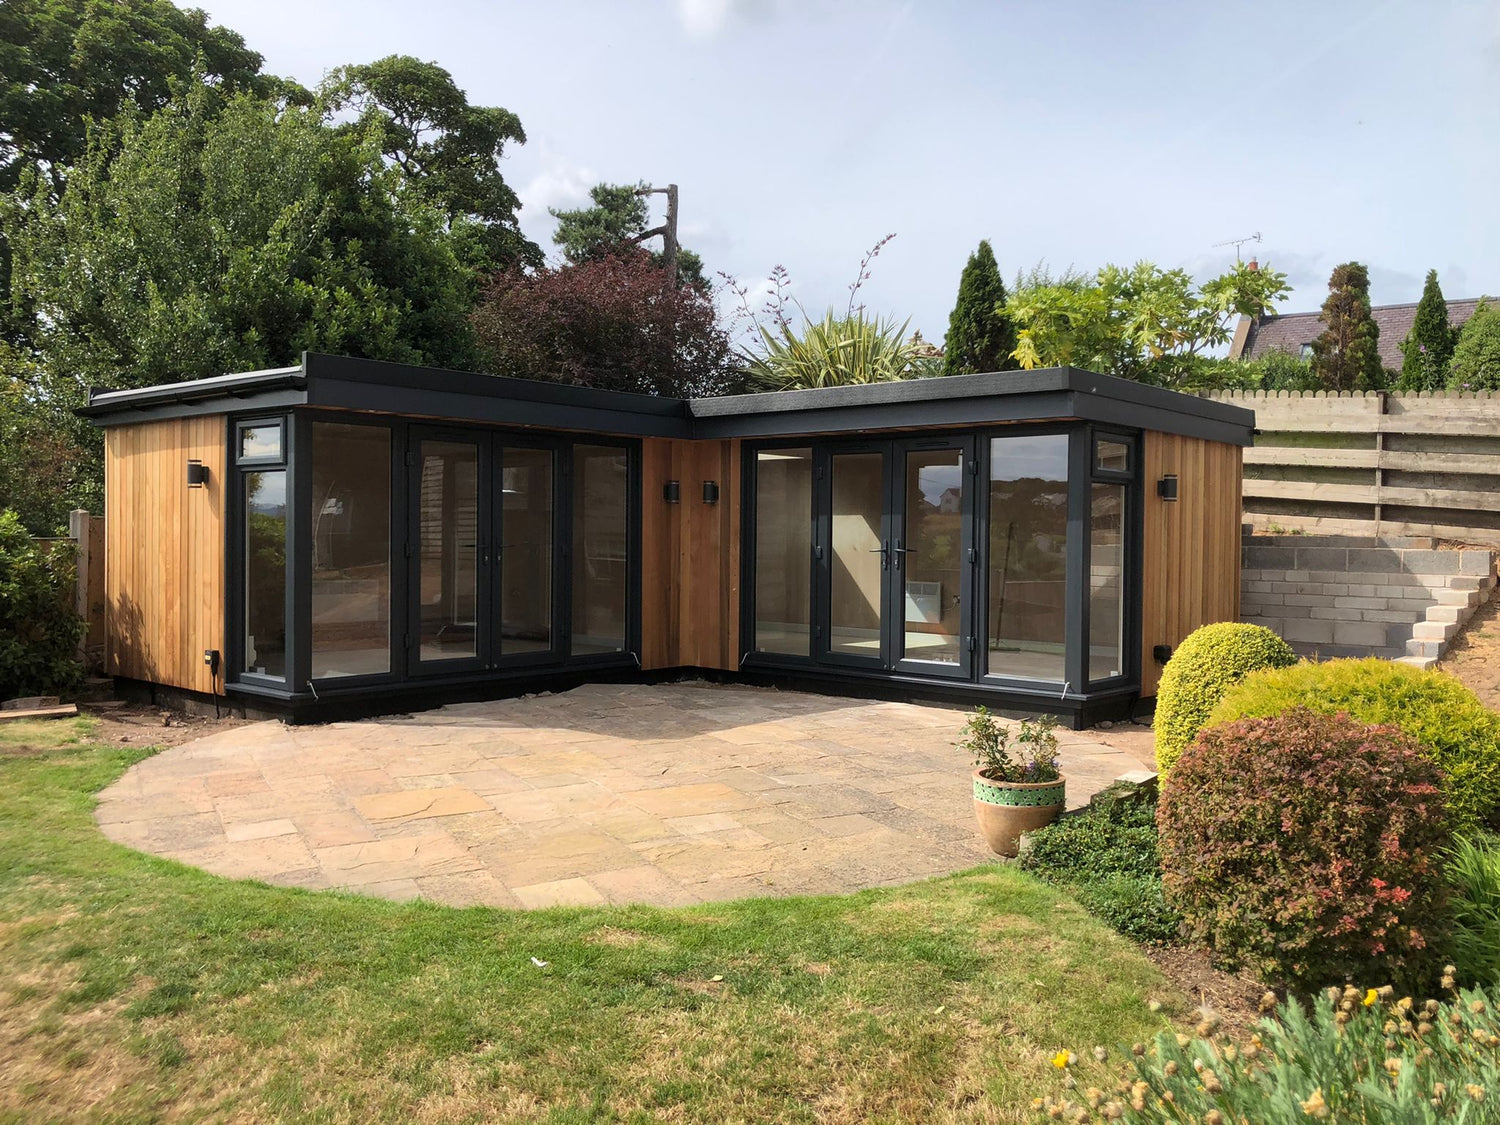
[1152,621,1298,774]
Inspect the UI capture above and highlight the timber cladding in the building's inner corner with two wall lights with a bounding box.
[641,438,740,671]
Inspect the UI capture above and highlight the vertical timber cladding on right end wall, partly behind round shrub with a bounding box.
[1140,431,1241,698]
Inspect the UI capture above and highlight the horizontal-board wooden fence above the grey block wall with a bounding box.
[1209,392,1500,546]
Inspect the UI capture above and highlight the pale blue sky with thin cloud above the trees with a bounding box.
[197,0,1500,341]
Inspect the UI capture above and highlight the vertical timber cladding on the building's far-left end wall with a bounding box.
[104,414,228,695]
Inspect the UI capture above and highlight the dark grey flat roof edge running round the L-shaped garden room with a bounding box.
[78,353,1256,446]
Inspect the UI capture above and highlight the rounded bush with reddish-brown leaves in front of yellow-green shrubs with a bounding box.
[1157,708,1449,987]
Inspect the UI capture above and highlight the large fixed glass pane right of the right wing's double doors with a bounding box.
[986,434,1068,681]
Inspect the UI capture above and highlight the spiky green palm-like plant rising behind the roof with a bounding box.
[744,309,929,390]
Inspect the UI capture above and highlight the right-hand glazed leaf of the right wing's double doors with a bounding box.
[891,446,971,675]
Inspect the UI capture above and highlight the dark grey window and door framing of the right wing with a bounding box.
[740,420,1145,705]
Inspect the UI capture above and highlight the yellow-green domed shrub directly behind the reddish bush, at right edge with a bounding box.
[1206,657,1500,833]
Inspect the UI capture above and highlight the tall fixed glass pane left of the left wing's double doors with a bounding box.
[312,422,390,680]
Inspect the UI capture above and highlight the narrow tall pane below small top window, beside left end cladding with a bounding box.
[245,470,287,680]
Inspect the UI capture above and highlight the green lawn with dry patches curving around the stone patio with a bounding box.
[0,725,1185,1124]
